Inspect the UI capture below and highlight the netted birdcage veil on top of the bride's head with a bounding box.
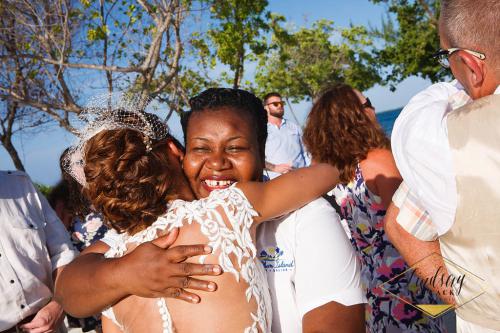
[63,93,169,187]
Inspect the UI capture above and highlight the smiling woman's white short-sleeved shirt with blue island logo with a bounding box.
[257,198,366,333]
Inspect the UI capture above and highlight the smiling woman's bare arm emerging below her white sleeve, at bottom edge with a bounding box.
[302,301,366,333]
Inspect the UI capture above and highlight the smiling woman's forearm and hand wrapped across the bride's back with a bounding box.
[55,229,222,317]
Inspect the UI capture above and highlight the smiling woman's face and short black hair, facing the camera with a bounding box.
[182,89,267,198]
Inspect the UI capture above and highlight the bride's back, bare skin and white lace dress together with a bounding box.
[103,186,272,333]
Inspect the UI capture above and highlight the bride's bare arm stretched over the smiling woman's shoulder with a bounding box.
[237,163,339,223]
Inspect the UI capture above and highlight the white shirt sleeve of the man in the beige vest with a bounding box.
[391,80,500,236]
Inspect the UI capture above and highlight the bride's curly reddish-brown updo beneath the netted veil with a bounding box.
[84,129,175,234]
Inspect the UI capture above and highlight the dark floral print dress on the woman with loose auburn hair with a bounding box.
[329,164,446,333]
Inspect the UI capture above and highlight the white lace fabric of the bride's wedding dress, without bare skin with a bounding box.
[103,185,272,333]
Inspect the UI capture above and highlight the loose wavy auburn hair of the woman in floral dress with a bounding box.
[304,84,390,184]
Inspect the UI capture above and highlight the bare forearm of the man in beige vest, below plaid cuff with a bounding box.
[384,203,455,304]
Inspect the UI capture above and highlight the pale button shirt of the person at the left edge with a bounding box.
[0,171,77,331]
